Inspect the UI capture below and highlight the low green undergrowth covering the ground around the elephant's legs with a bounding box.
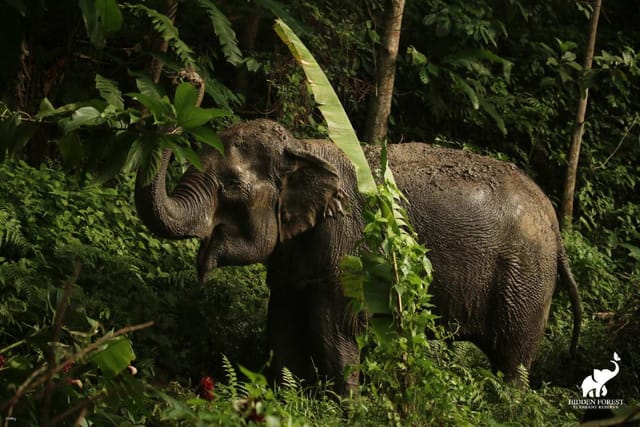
[0,162,639,425]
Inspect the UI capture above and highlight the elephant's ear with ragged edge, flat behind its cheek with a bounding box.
[278,148,346,242]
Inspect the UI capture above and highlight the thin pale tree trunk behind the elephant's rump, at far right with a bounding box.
[560,0,602,226]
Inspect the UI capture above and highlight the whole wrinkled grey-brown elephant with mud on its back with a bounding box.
[136,120,580,393]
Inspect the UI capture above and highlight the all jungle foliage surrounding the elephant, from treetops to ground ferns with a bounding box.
[0,0,640,425]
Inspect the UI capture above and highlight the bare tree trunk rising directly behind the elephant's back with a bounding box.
[364,0,405,142]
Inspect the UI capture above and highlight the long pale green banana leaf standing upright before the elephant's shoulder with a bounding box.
[274,19,377,193]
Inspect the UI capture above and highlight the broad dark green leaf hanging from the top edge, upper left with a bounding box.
[79,0,123,49]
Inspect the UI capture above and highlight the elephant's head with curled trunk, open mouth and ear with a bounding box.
[135,120,342,279]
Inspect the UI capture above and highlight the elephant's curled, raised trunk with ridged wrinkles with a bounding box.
[135,149,215,239]
